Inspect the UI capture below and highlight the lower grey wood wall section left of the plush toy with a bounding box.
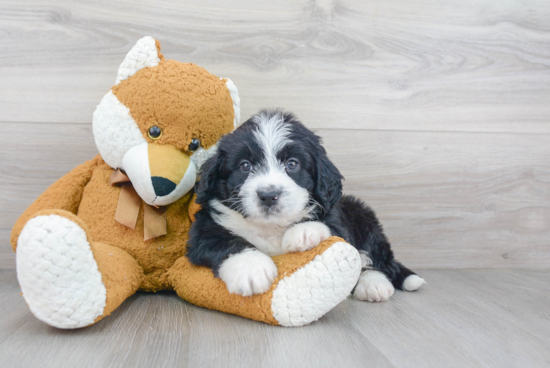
[0,123,97,269]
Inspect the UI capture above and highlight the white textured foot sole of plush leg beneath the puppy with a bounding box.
[271,242,361,327]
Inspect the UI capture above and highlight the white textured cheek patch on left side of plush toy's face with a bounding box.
[92,91,147,169]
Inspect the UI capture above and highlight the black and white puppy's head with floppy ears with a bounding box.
[197,111,343,226]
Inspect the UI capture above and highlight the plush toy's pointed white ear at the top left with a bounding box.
[115,36,164,84]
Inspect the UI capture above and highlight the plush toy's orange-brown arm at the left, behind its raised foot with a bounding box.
[10,155,101,252]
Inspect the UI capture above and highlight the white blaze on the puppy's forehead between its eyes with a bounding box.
[254,113,291,170]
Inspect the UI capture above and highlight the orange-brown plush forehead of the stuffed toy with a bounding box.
[112,60,234,150]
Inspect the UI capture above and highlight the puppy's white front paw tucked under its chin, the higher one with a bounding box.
[282,221,330,253]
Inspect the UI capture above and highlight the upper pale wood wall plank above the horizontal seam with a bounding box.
[0,0,550,133]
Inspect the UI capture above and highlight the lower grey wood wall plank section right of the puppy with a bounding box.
[330,130,550,268]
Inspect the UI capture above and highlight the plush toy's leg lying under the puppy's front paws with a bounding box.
[169,237,361,326]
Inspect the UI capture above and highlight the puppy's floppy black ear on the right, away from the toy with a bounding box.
[313,146,344,212]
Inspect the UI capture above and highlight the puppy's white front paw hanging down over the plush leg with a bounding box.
[218,249,277,296]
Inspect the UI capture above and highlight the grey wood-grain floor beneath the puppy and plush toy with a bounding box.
[0,270,550,368]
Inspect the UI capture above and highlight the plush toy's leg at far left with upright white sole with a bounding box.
[16,210,143,329]
